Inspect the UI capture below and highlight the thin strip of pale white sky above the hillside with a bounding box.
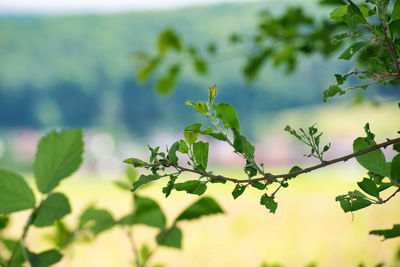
[0,0,256,14]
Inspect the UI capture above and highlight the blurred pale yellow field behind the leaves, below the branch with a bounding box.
[6,168,400,267]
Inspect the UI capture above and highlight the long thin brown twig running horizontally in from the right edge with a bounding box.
[165,136,400,184]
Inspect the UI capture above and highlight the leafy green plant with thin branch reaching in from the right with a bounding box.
[130,0,400,238]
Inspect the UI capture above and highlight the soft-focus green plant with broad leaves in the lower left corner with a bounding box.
[0,130,223,267]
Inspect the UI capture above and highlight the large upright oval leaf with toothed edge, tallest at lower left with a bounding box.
[34,130,83,194]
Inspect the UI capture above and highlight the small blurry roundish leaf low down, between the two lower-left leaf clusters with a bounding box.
[79,207,115,235]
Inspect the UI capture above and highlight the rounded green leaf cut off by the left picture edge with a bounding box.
[0,169,35,214]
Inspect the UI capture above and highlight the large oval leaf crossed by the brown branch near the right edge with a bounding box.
[353,137,389,177]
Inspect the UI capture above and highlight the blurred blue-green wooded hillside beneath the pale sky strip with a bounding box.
[0,1,388,135]
